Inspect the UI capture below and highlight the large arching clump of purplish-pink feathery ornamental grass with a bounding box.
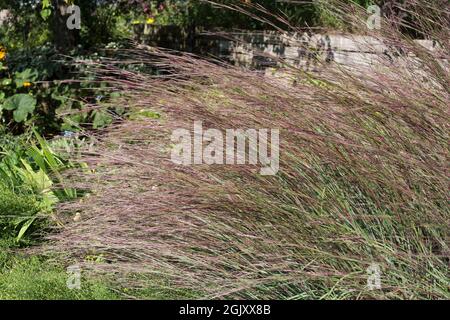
[44,0,450,299]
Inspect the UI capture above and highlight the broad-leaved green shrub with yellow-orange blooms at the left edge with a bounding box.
[0,46,127,135]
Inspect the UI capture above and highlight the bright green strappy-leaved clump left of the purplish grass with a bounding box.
[0,127,77,242]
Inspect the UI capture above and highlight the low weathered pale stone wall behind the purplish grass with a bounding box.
[134,26,437,70]
